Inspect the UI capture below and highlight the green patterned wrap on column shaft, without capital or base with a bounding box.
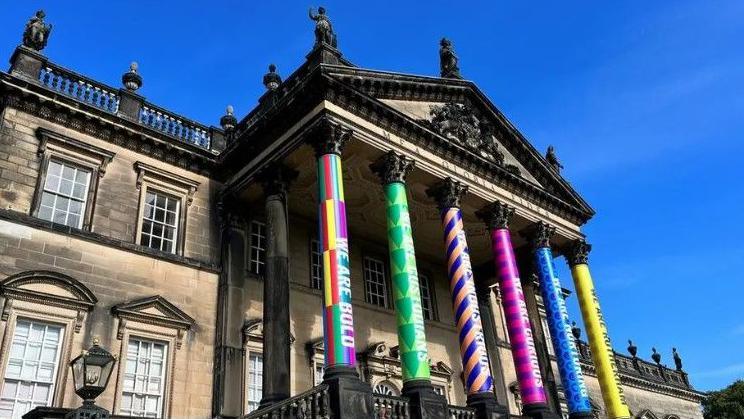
[385,182,429,382]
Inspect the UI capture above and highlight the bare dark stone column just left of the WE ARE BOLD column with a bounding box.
[259,163,297,408]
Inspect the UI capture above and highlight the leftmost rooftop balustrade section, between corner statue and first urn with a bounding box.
[39,62,119,113]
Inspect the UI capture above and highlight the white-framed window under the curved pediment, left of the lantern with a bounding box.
[0,317,66,418]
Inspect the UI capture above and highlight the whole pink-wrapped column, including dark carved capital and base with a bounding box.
[479,201,554,418]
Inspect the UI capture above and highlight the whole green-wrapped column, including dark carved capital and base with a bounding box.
[370,151,447,419]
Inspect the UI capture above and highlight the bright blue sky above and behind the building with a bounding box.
[0,0,744,390]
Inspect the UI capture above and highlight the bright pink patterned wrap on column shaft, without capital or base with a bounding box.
[491,228,547,408]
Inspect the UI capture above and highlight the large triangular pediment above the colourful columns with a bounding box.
[325,66,594,224]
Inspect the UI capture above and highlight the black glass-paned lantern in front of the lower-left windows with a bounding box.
[65,339,116,419]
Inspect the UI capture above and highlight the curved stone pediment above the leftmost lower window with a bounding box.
[0,271,98,332]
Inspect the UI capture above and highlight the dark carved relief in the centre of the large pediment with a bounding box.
[430,103,504,165]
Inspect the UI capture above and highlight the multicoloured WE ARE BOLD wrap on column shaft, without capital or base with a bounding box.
[318,154,356,368]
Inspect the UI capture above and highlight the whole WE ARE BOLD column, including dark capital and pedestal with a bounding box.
[309,116,374,419]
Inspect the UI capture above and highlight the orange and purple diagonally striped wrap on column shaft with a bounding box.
[442,208,493,394]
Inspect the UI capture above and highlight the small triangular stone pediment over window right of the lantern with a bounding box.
[111,295,196,344]
